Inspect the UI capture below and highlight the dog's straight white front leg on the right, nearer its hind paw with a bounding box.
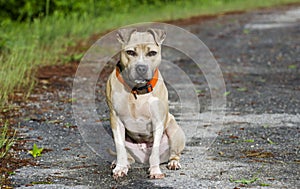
[149,100,166,179]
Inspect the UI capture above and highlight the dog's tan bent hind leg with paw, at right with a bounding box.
[166,113,185,170]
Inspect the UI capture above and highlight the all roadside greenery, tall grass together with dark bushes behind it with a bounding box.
[0,0,299,107]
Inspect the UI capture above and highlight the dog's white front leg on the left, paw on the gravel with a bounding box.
[110,112,129,179]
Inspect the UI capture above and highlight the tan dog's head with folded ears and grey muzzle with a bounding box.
[117,29,166,86]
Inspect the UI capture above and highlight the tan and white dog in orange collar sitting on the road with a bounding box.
[106,29,185,179]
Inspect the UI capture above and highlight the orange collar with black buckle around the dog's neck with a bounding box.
[116,63,158,99]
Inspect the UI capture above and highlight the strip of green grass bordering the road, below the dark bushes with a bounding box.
[0,0,300,108]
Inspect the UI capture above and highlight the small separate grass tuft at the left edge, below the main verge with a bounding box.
[0,122,16,159]
